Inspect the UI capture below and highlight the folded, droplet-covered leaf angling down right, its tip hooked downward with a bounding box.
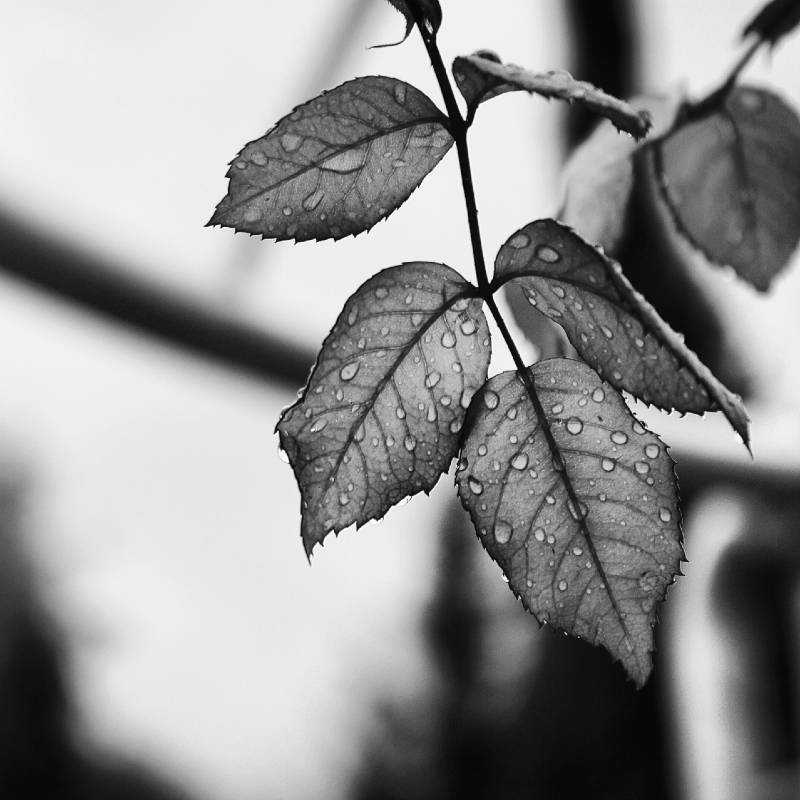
[493,219,749,445]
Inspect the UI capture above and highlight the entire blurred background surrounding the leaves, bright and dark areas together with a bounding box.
[0,0,800,800]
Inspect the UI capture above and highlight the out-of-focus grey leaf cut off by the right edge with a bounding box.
[654,86,800,291]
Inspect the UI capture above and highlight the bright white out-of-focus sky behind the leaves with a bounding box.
[0,0,800,800]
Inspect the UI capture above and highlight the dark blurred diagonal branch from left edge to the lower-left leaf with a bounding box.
[0,208,314,387]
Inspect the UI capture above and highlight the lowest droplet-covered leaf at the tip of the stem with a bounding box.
[456,359,683,686]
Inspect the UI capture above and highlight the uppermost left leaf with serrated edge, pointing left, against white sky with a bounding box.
[209,76,453,242]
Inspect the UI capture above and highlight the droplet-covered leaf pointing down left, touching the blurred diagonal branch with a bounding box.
[277,262,491,554]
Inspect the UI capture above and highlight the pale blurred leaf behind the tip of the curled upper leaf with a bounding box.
[557,93,683,252]
